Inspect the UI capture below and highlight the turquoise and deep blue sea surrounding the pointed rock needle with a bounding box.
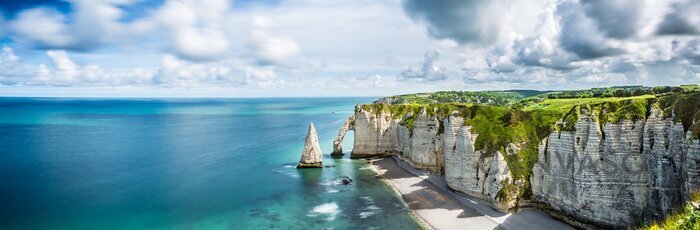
[0,98,418,230]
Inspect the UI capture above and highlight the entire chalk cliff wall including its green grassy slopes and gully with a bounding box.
[340,91,700,228]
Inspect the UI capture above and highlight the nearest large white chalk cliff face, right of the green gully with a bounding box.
[531,109,700,228]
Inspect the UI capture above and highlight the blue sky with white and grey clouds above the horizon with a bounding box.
[0,0,700,97]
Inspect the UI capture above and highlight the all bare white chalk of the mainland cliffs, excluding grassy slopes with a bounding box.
[336,103,700,228]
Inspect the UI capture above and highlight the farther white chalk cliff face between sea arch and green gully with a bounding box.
[336,106,517,211]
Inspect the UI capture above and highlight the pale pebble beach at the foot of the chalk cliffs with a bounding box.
[370,156,574,229]
